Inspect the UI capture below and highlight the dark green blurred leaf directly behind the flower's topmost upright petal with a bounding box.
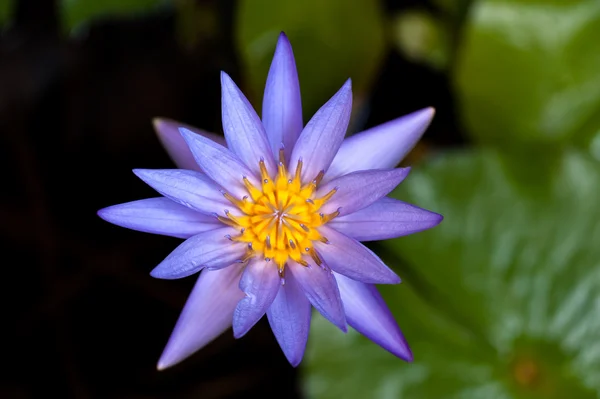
[235,0,385,119]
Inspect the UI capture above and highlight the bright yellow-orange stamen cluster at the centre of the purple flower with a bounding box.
[219,150,339,276]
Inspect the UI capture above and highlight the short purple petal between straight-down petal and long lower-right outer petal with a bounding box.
[288,262,348,332]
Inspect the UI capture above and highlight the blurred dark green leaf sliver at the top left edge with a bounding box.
[61,0,171,32]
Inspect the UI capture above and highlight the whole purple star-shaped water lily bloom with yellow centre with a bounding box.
[99,33,442,369]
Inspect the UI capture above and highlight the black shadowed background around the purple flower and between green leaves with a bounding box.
[0,0,463,399]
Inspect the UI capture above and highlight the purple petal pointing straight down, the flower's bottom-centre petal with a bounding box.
[267,273,311,367]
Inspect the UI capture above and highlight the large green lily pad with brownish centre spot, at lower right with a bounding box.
[304,150,600,399]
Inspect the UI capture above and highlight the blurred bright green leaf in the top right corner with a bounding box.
[454,0,600,146]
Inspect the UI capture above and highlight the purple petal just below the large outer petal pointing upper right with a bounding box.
[316,168,410,219]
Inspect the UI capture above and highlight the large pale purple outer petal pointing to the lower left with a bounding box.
[157,266,244,370]
